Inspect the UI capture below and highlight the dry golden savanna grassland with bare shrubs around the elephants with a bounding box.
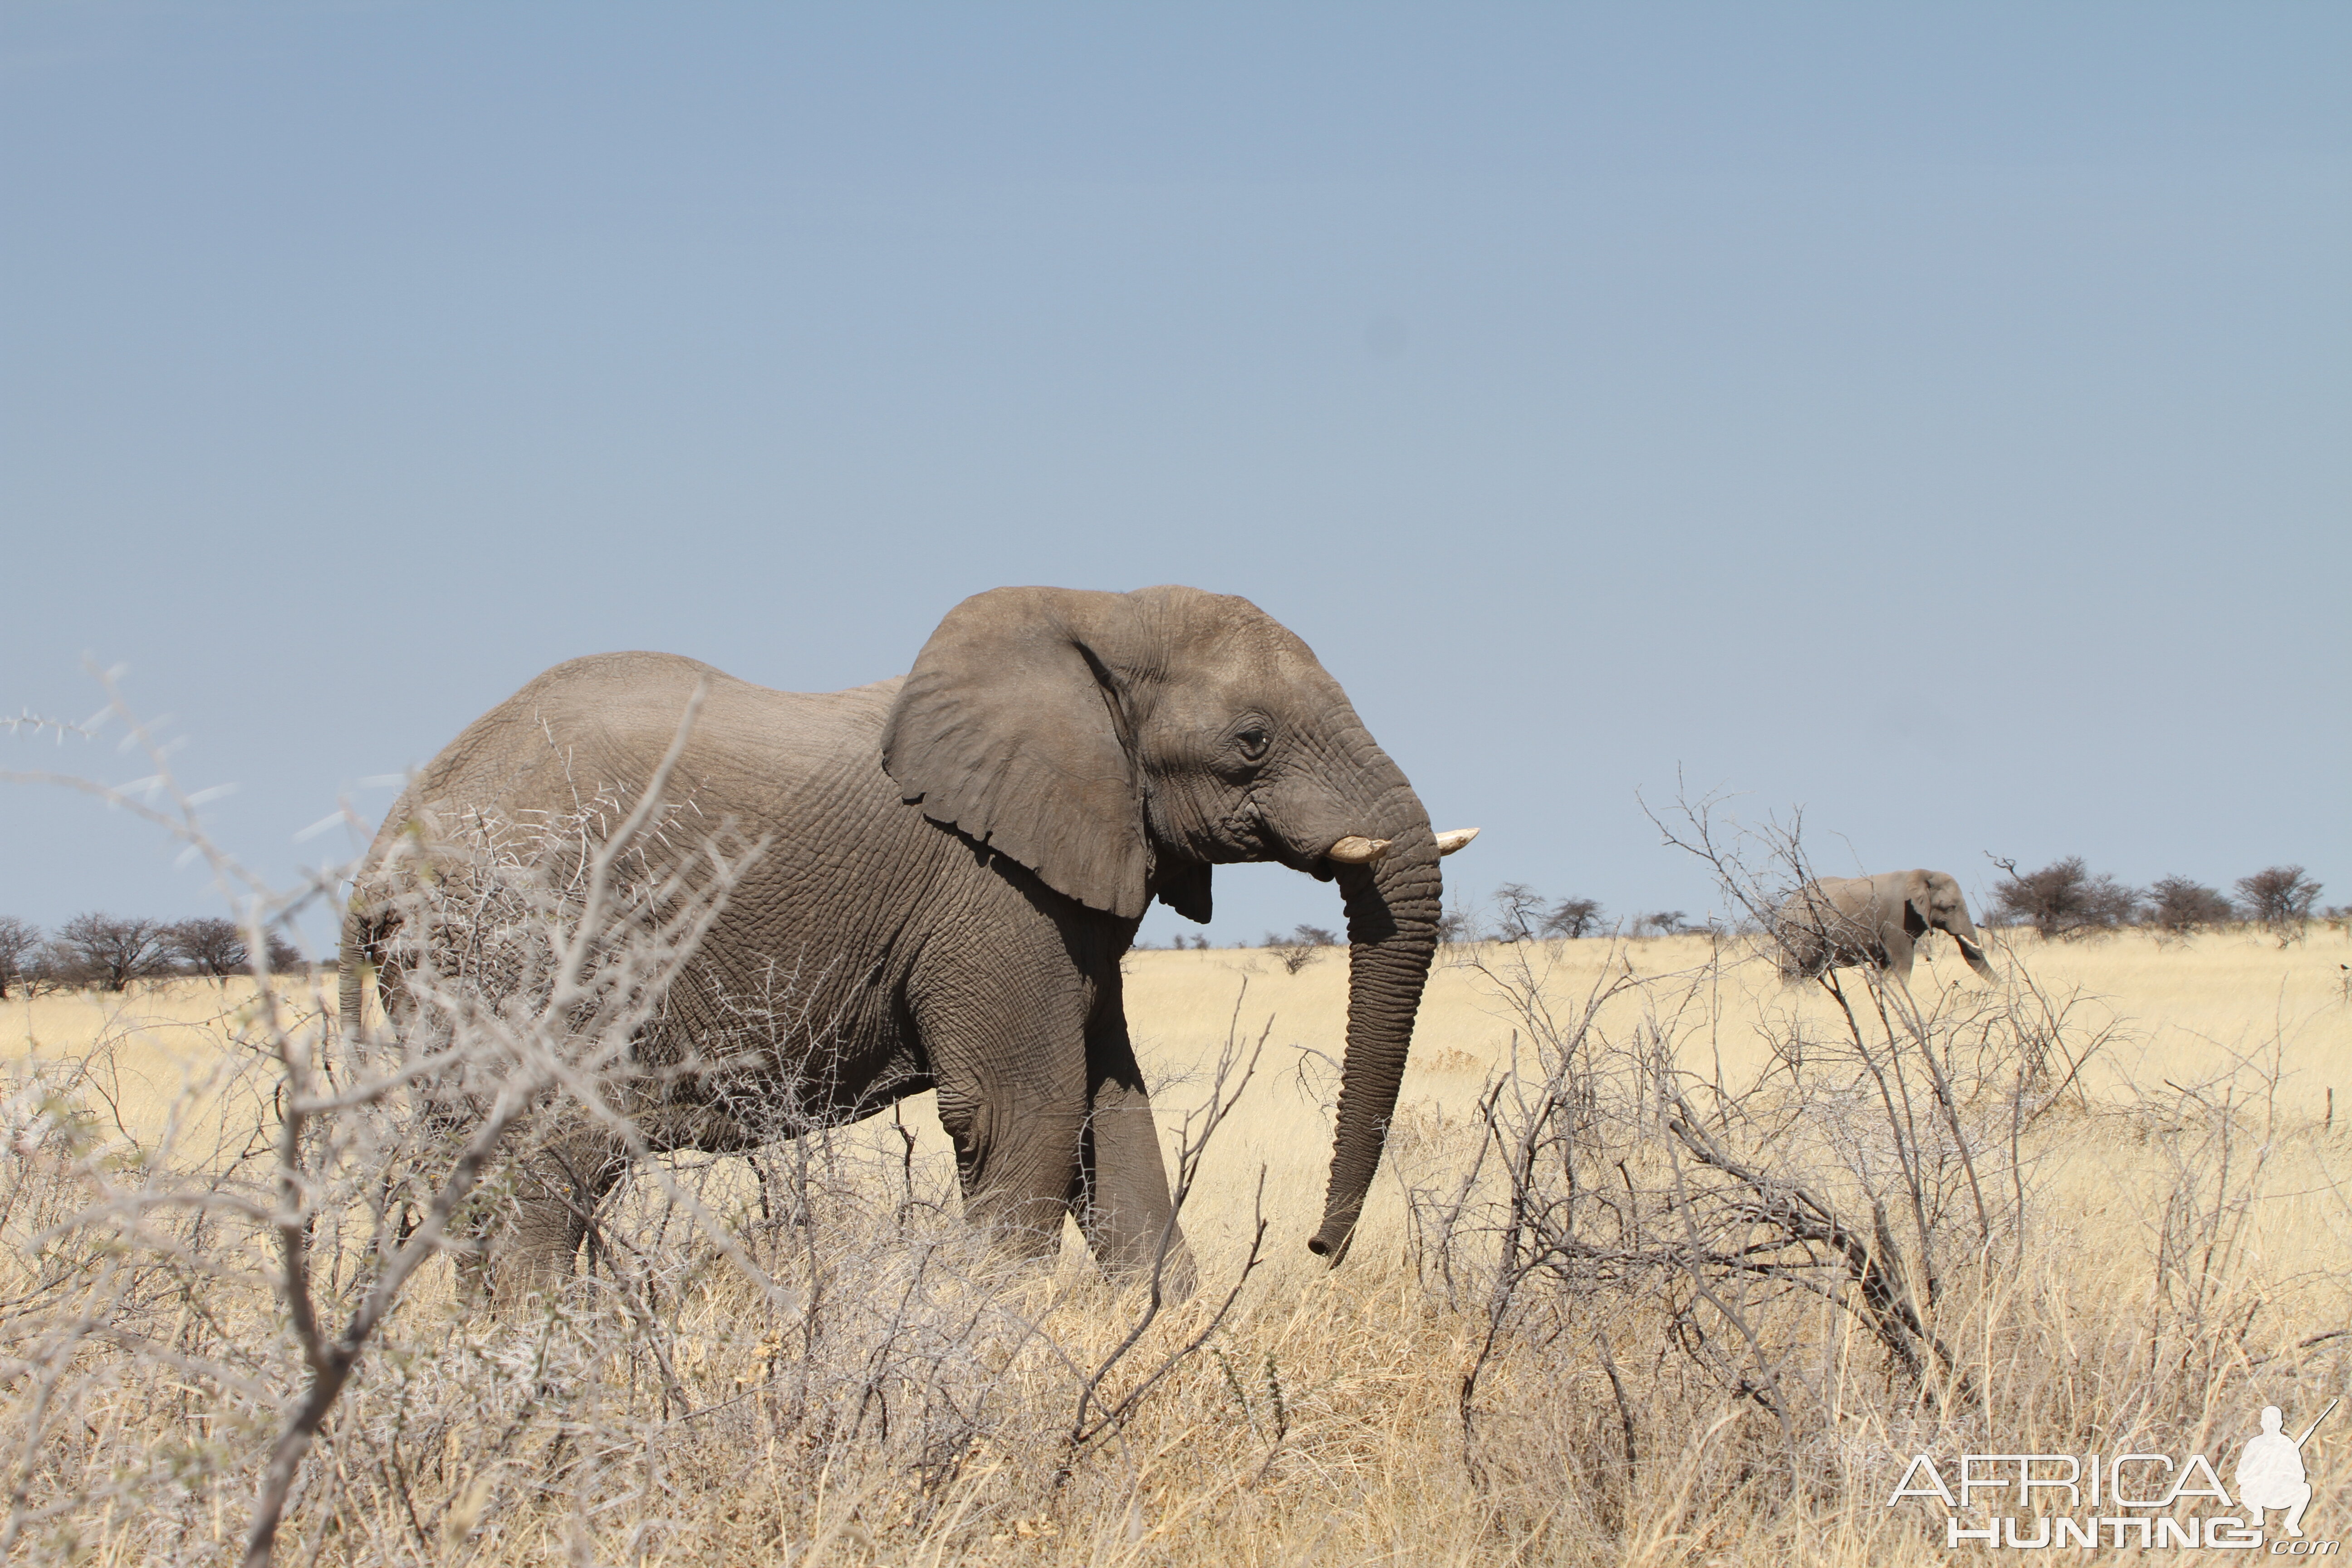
[0,926,2352,1563]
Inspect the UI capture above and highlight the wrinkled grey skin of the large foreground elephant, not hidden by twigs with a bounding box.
[343,588,1440,1295]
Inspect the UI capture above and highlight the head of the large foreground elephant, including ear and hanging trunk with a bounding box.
[882,588,1463,1262]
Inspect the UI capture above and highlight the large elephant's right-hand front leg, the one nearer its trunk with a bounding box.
[1070,1015,1197,1300]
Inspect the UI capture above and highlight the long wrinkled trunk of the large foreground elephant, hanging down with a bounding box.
[1308,823,1440,1265]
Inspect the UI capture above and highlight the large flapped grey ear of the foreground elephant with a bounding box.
[882,588,1150,919]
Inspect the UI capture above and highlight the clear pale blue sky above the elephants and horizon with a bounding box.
[0,2,2352,941]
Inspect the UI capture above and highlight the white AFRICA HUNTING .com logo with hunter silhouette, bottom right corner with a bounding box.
[1886,1399,2338,1556]
